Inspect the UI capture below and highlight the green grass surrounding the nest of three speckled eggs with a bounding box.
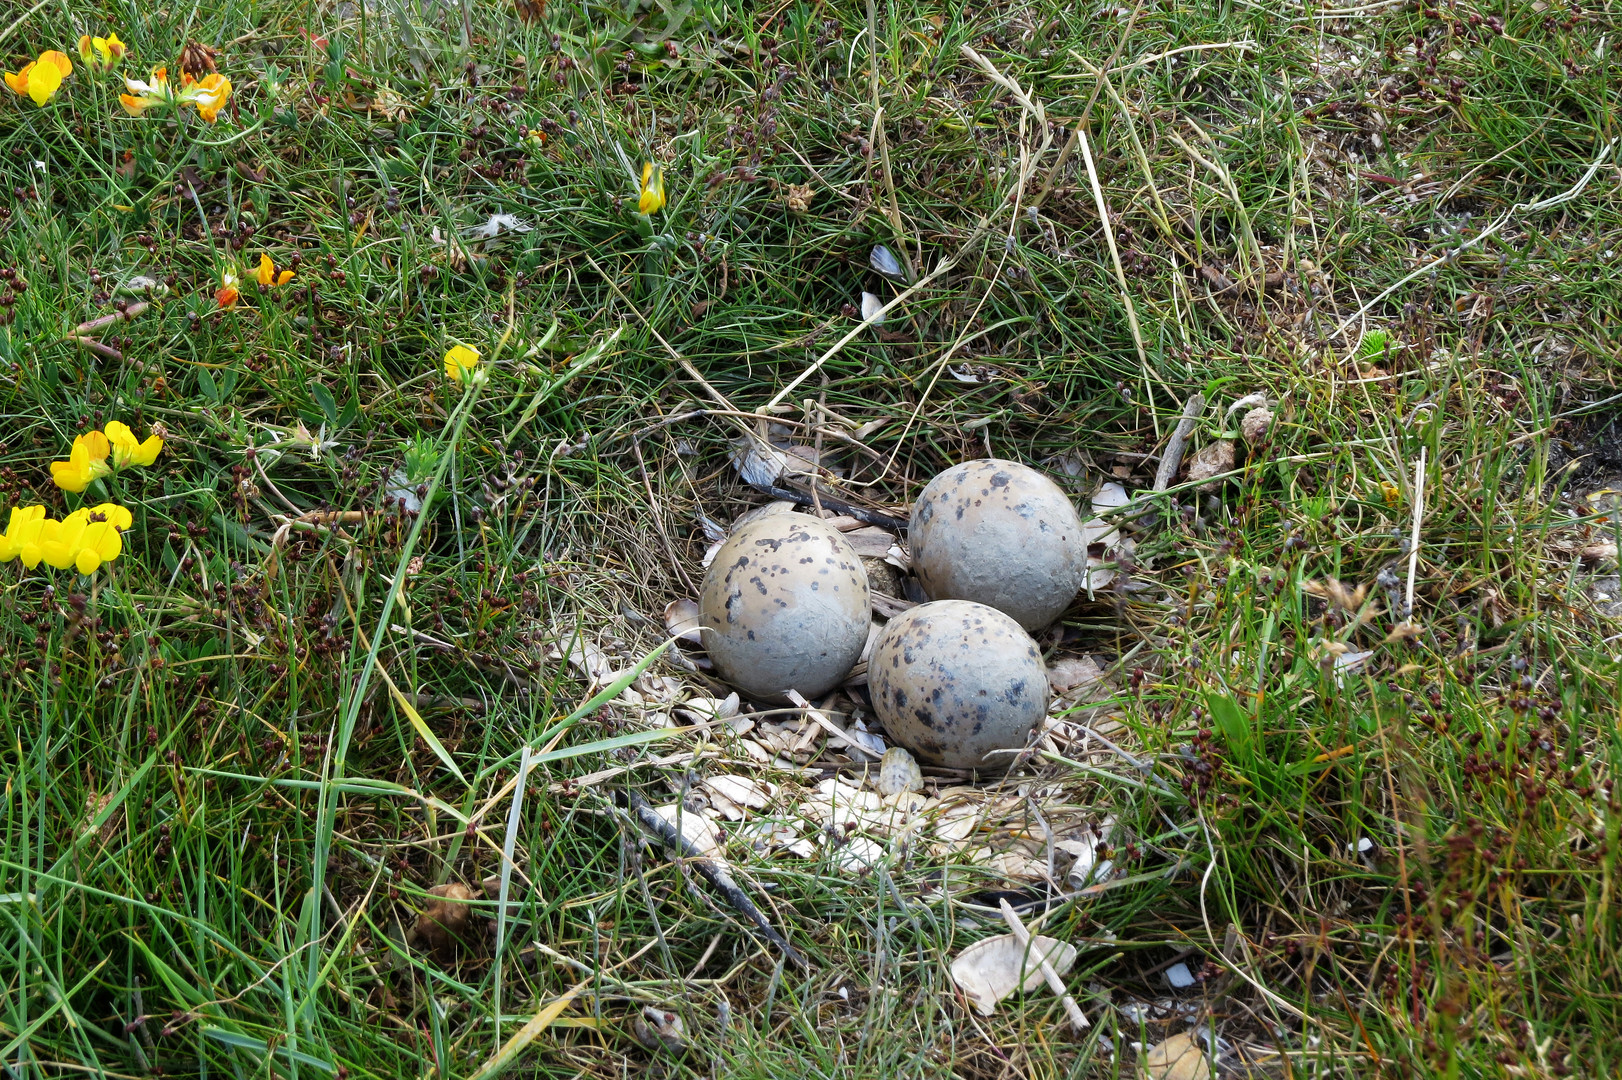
[0,0,1622,1078]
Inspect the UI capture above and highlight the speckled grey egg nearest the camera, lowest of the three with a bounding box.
[868,600,1048,774]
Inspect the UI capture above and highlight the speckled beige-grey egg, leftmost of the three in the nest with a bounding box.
[699,514,873,702]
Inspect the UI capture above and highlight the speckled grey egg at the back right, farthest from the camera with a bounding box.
[907,457,1087,629]
